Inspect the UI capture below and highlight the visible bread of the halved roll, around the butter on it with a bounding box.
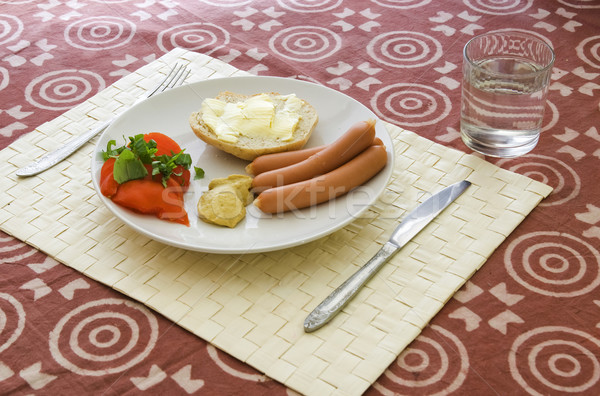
[189,92,318,161]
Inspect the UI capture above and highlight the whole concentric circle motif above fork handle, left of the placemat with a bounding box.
[25,69,105,110]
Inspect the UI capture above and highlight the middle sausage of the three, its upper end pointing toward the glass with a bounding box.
[252,120,375,193]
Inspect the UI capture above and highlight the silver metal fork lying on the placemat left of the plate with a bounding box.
[16,65,190,177]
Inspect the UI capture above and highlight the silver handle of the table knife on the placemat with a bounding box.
[304,242,398,333]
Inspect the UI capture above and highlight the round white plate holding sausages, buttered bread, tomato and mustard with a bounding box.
[91,77,393,253]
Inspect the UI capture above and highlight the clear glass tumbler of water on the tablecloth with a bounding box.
[460,31,554,158]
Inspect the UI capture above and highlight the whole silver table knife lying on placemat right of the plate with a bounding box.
[304,180,471,333]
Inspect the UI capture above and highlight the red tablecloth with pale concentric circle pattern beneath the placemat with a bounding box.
[0,0,600,395]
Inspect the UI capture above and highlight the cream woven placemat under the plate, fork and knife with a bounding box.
[0,49,551,396]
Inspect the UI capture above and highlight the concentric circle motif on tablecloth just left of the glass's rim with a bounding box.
[367,31,443,69]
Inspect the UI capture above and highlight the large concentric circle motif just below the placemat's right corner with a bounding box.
[504,231,600,297]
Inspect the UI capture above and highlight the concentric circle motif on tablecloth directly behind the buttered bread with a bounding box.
[269,26,342,62]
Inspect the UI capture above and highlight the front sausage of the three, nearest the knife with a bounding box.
[254,146,387,213]
